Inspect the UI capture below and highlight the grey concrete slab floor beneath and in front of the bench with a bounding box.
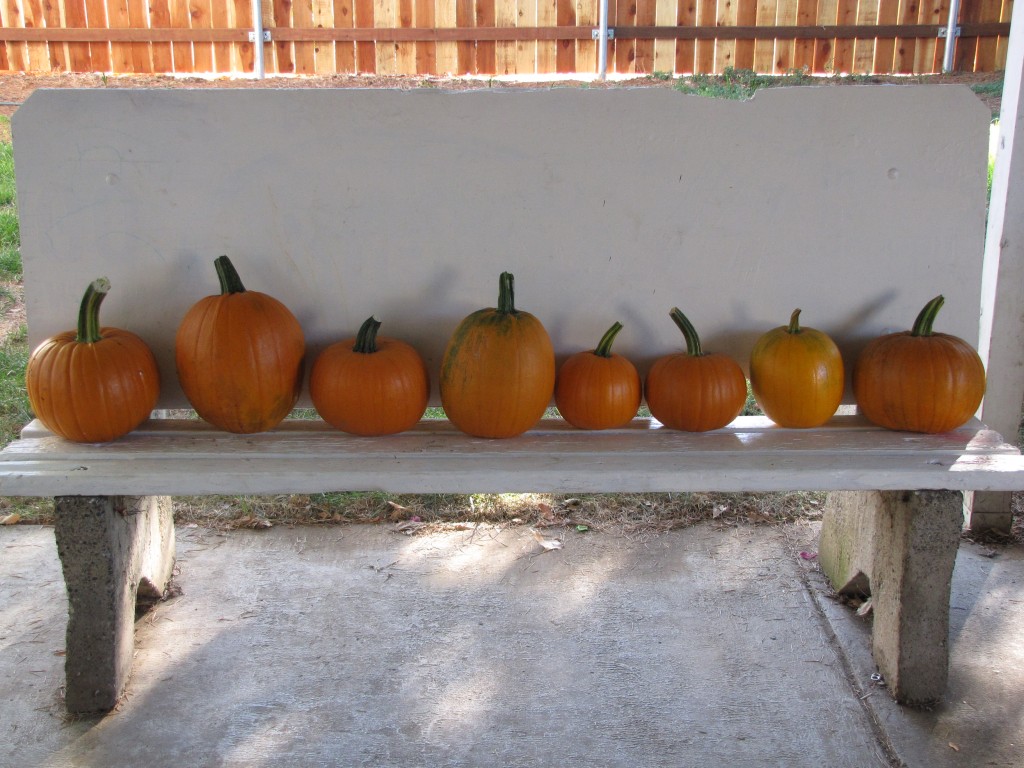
[0,525,1024,768]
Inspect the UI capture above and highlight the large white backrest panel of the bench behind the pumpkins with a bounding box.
[13,86,989,408]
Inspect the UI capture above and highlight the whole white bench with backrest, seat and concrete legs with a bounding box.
[0,86,1024,712]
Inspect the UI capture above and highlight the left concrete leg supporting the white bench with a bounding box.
[54,496,174,714]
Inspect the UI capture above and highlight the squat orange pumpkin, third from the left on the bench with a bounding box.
[309,316,430,435]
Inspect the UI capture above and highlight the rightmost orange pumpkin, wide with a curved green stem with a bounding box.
[853,296,985,433]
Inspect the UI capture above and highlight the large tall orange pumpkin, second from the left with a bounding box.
[174,256,305,433]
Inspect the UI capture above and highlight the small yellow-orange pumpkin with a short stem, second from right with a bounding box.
[751,309,845,428]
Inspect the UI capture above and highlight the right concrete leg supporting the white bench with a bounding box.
[819,490,964,707]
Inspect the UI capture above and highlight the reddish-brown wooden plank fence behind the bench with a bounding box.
[0,0,1013,75]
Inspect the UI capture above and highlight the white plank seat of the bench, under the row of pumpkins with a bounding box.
[0,415,1024,496]
